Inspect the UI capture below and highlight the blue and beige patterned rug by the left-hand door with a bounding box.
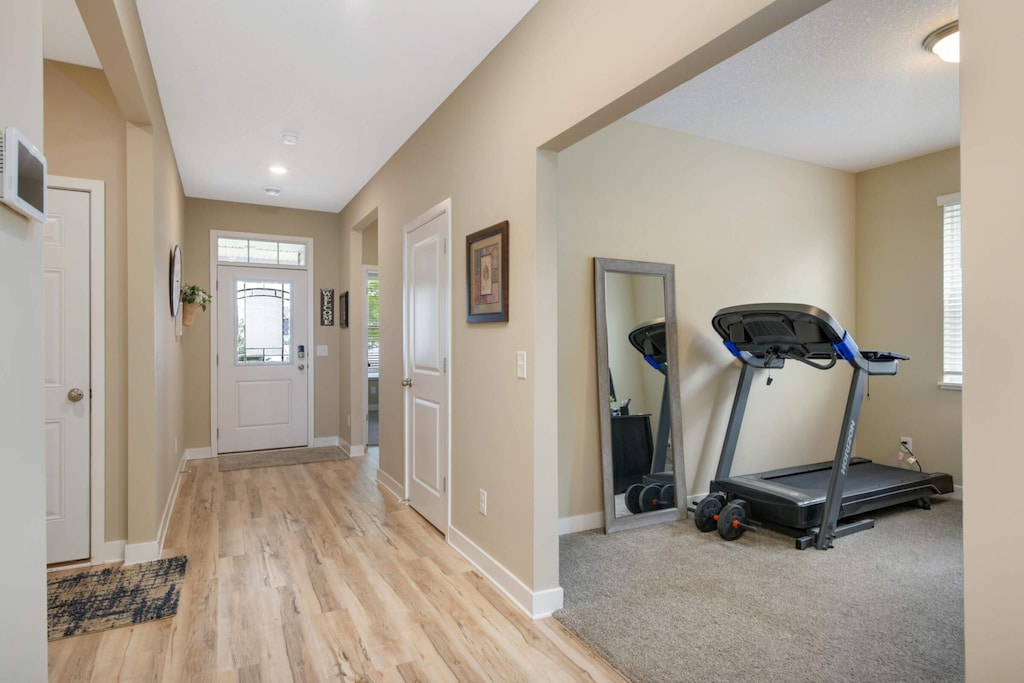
[46,555,188,640]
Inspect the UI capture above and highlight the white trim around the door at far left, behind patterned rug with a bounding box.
[46,175,105,564]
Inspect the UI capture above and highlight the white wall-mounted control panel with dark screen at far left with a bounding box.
[0,126,46,223]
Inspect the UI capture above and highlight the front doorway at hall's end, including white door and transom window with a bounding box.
[211,232,313,455]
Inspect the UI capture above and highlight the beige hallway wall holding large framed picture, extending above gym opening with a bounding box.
[341,0,820,591]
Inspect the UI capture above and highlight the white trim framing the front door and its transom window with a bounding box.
[210,230,319,458]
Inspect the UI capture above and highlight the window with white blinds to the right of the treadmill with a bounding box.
[938,193,964,386]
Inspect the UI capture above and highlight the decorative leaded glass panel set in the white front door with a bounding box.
[234,280,292,365]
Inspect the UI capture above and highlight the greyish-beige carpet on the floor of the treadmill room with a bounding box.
[555,497,962,683]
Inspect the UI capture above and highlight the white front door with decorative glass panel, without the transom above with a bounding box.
[216,265,311,453]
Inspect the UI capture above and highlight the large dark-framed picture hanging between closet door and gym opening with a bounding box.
[466,220,509,323]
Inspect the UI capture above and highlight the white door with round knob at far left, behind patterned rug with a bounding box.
[43,188,91,563]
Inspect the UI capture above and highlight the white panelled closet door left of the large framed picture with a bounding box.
[402,208,450,533]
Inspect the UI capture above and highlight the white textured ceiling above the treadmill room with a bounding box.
[629,0,959,172]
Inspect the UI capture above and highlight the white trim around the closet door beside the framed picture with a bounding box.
[401,198,455,541]
